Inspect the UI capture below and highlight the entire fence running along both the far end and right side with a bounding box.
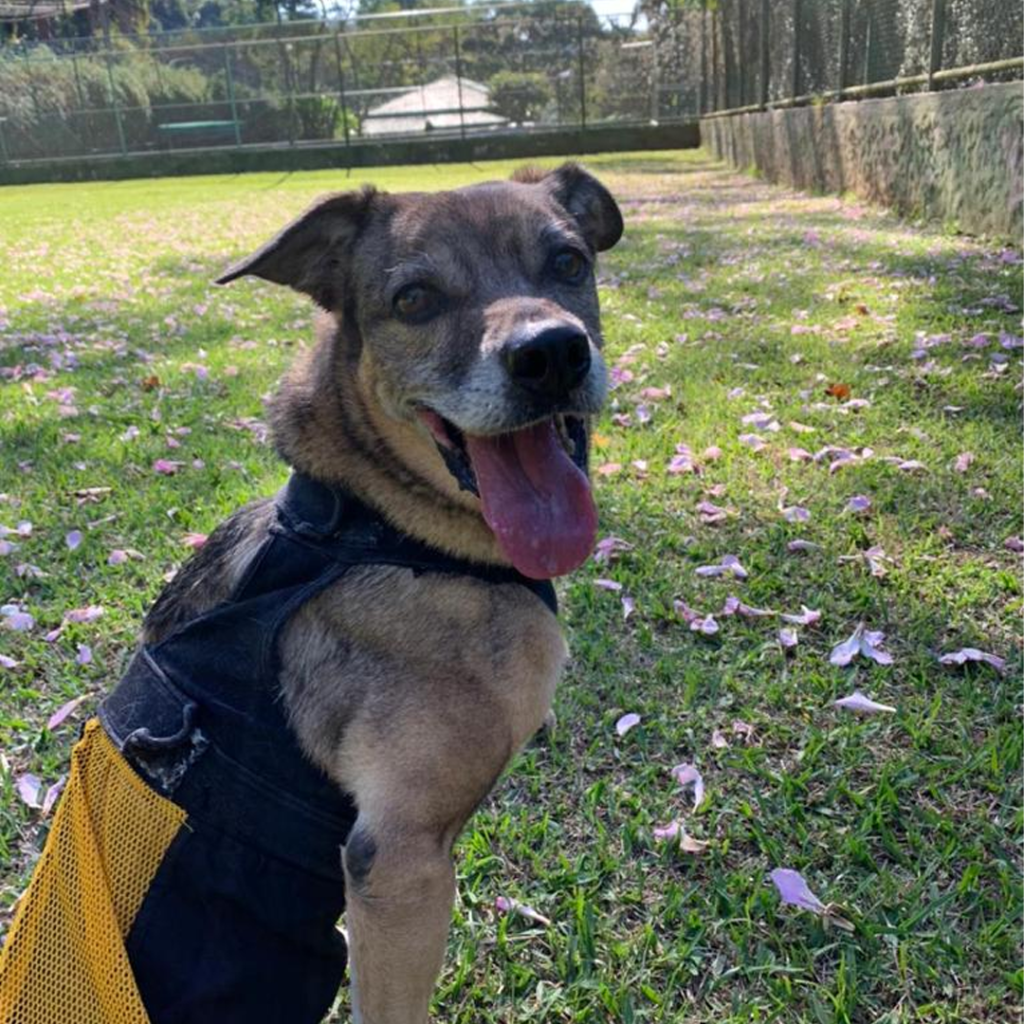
[0,0,1024,165]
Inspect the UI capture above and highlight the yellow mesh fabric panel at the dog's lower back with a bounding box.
[0,720,185,1024]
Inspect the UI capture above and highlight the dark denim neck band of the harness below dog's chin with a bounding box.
[276,471,558,615]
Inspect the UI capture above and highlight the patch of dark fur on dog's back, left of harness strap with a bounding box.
[142,499,275,643]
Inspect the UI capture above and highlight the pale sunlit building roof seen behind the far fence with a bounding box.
[362,75,508,135]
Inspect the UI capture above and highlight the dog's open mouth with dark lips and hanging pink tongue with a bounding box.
[419,408,597,580]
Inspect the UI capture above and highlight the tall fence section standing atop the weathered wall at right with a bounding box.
[701,0,1024,115]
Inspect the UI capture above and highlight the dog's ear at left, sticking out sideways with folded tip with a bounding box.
[216,187,378,310]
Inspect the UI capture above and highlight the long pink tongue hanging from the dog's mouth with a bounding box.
[466,420,597,580]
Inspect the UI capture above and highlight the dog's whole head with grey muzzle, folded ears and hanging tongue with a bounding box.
[219,164,623,578]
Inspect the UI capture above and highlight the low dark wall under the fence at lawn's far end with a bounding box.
[0,122,700,185]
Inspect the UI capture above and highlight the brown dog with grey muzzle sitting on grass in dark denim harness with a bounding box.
[0,164,623,1024]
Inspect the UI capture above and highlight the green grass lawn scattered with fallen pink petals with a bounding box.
[0,153,1022,1024]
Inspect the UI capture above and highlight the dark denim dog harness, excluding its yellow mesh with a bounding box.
[99,473,557,1024]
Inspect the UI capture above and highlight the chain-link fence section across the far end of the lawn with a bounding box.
[0,2,698,163]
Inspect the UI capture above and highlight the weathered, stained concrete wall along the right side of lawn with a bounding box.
[700,82,1024,243]
